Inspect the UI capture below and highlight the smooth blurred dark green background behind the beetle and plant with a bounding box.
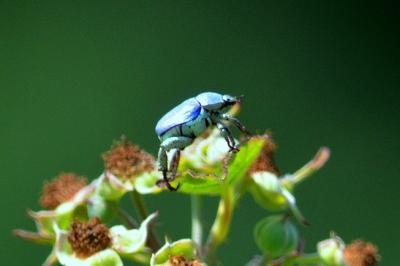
[0,0,400,265]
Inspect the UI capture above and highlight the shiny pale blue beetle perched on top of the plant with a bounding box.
[155,92,251,191]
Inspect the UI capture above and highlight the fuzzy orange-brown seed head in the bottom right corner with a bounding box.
[344,240,380,266]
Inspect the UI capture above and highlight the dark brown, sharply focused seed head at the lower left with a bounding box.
[68,217,111,258]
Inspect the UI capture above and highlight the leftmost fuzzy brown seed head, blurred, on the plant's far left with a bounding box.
[39,173,87,209]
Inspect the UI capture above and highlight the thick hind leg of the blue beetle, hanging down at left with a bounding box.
[157,136,193,191]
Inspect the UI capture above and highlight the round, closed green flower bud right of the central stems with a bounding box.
[254,215,299,259]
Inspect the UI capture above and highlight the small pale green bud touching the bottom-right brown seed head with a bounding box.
[317,233,347,266]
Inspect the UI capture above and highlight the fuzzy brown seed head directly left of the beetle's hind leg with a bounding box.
[102,136,154,179]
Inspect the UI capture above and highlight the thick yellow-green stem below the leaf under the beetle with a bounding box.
[204,186,234,262]
